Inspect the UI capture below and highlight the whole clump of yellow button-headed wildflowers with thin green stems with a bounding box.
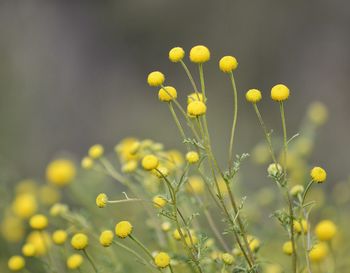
[2,45,344,273]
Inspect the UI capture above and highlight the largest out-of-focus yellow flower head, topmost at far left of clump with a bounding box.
[46,159,76,187]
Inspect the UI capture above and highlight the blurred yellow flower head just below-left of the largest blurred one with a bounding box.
[12,193,38,219]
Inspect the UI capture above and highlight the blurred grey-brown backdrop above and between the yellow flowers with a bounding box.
[0,0,350,179]
